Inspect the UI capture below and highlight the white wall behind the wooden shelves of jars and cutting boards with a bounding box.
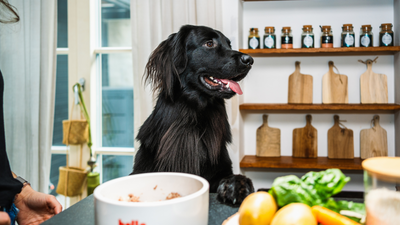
[223,0,397,191]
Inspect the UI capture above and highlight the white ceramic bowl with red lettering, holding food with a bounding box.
[94,173,209,225]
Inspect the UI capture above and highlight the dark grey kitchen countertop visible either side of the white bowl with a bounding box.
[42,193,239,225]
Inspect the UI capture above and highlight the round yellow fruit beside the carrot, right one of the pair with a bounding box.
[271,203,317,225]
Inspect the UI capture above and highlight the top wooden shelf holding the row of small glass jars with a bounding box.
[239,46,400,57]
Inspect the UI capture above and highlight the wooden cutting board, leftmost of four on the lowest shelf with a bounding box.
[256,115,281,157]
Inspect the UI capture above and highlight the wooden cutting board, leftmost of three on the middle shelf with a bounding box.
[288,61,313,104]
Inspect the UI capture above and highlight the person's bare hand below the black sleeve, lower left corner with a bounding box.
[14,185,62,225]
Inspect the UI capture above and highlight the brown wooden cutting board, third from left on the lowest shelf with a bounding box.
[328,115,354,159]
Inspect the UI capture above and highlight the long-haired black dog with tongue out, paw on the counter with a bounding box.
[132,25,254,205]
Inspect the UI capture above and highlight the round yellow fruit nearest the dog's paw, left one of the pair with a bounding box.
[239,191,278,225]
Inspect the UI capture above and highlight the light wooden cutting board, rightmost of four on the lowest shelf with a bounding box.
[360,115,388,159]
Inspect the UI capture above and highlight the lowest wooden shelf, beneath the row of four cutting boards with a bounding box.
[240,155,362,170]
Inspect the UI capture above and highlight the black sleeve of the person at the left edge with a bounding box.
[0,71,22,207]
